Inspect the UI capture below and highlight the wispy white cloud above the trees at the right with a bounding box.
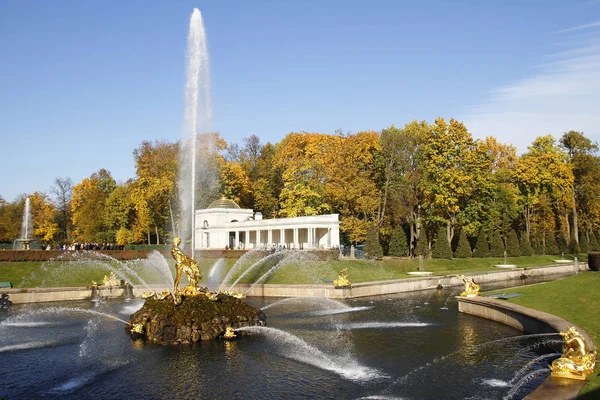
[463,25,600,153]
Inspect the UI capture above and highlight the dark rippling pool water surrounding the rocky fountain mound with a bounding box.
[0,276,560,399]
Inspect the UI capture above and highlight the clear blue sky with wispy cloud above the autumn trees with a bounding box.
[0,0,600,201]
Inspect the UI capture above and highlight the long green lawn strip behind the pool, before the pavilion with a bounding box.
[0,256,580,288]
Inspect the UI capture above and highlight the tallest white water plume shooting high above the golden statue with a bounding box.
[179,8,216,253]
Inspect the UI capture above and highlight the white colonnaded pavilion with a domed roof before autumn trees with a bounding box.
[195,199,340,250]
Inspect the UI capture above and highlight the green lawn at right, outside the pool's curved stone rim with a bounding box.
[492,271,600,399]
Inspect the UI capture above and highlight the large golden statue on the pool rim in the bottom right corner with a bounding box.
[550,326,596,380]
